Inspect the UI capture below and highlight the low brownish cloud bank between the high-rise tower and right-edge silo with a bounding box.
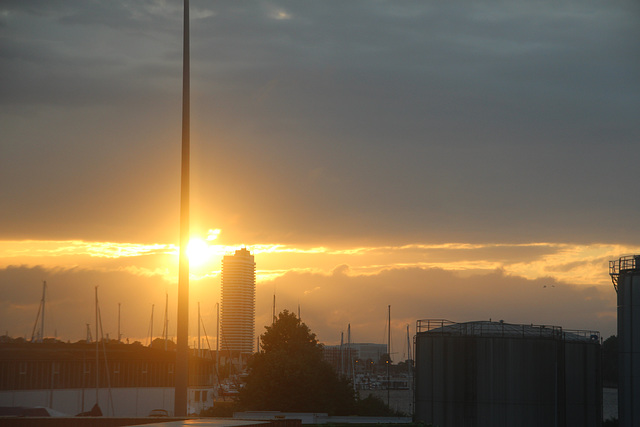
[258,265,616,360]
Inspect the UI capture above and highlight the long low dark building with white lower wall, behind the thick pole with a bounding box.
[0,342,217,417]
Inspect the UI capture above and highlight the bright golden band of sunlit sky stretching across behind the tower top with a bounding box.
[0,241,640,286]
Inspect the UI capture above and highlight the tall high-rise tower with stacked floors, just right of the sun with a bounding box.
[220,248,256,354]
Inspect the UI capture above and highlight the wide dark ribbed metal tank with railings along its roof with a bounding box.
[415,319,602,427]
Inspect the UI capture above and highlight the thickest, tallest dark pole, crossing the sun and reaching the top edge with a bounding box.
[174,0,190,417]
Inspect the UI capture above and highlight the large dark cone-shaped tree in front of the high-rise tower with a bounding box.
[239,310,356,415]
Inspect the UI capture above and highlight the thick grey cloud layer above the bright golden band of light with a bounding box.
[0,1,640,243]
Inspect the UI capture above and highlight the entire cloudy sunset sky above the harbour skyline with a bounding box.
[0,0,640,361]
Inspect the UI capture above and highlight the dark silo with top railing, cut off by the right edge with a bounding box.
[609,255,640,427]
